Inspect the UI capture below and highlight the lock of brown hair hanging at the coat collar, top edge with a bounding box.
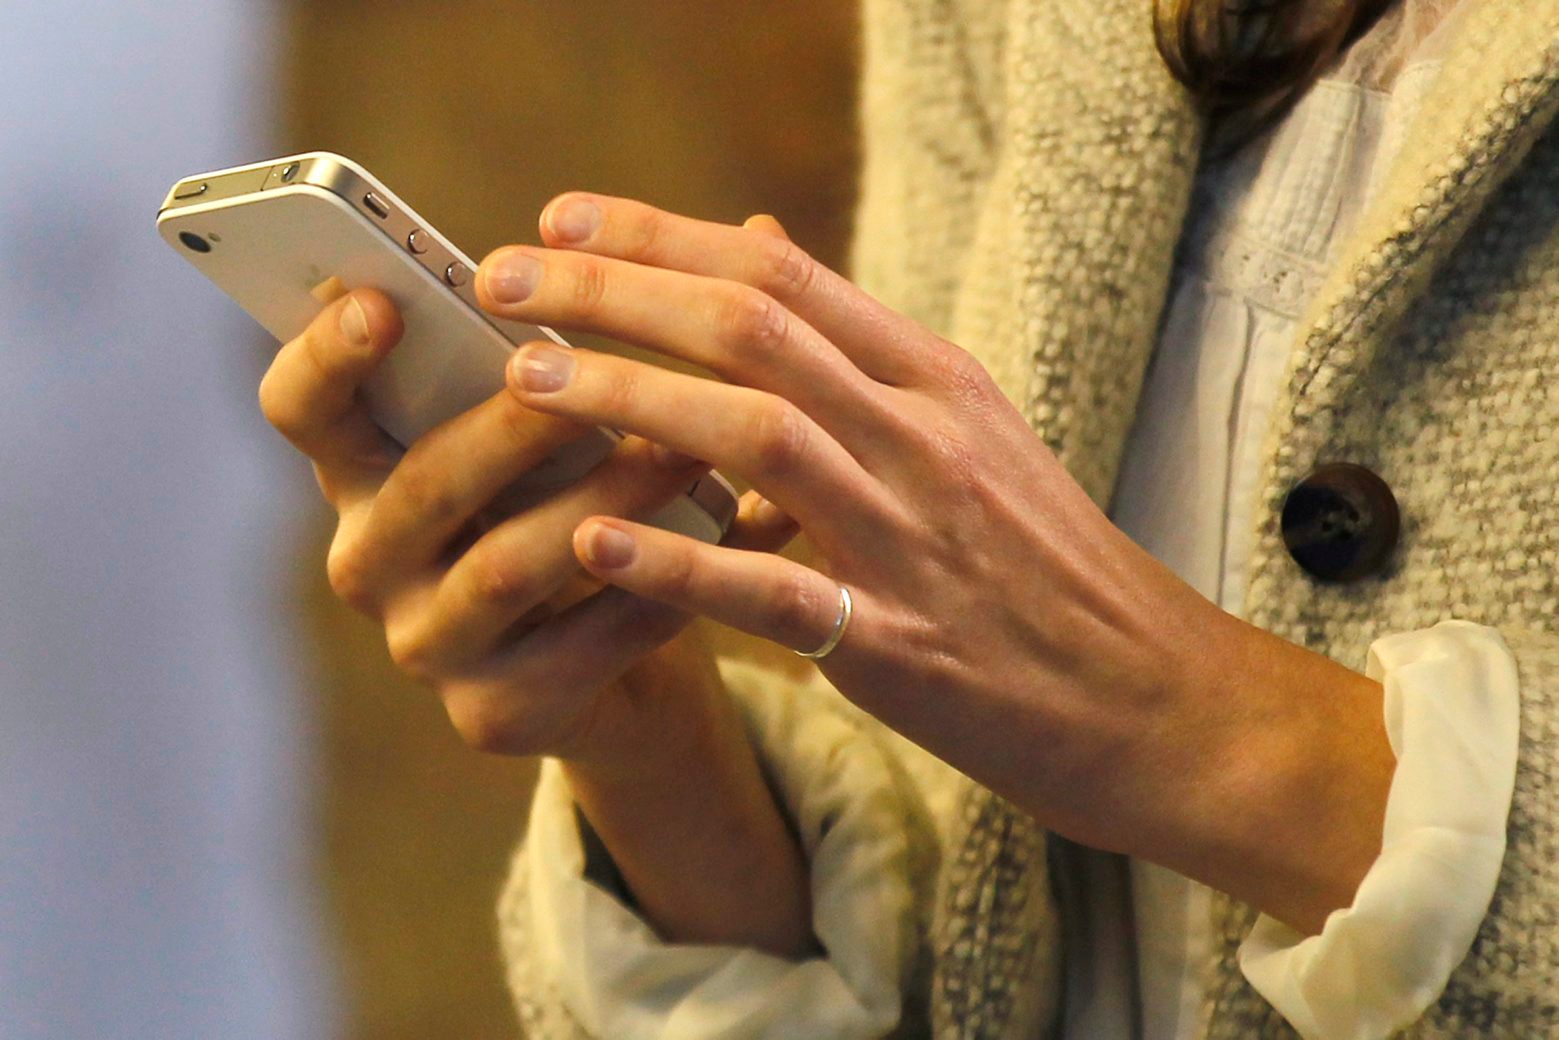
[1151,0,1392,150]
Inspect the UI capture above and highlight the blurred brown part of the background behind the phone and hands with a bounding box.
[282,0,856,1040]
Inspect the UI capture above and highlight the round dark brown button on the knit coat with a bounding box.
[1283,462,1402,582]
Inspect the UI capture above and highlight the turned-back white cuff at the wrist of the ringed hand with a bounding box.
[1239,621,1520,1040]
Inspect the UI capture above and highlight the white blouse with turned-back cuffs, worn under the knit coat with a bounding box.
[521,0,1518,1040]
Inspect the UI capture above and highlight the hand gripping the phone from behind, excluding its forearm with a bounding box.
[260,290,795,759]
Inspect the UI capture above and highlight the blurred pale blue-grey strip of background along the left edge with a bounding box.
[0,0,337,1040]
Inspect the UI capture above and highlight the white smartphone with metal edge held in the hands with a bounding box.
[157,151,736,543]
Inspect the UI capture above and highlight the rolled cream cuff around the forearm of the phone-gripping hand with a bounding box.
[522,664,915,1040]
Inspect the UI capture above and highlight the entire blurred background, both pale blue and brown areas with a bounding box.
[0,0,857,1040]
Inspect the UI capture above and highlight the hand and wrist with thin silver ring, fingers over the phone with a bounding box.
[477,195,1391,926]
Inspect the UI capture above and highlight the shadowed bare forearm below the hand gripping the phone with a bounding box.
[564,626,817,957]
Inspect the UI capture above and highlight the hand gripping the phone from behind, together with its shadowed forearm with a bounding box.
[260,290,814,956]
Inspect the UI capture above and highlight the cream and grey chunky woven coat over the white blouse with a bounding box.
[504,0,1559,1040]
